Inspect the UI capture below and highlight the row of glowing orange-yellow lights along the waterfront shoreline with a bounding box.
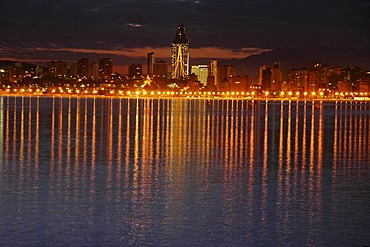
[6,88,370,97]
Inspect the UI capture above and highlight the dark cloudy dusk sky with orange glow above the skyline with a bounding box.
[0,0,370,70]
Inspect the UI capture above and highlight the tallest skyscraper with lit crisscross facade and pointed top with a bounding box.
[171,23,189,79]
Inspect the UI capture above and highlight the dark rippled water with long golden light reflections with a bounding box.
[0,97,370,246]
